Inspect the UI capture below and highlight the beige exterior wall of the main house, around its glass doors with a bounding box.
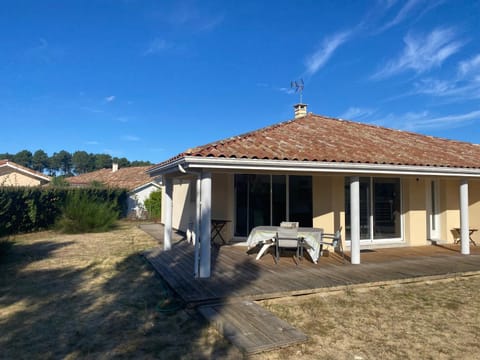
[166,173,480,246]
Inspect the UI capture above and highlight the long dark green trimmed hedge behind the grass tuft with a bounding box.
[0,187,128,236]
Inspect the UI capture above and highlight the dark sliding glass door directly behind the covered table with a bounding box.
[235,174,312,236]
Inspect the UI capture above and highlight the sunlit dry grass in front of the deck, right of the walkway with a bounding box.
[258,276,480,360]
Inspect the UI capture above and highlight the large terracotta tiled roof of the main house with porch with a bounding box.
[157,114,480,169]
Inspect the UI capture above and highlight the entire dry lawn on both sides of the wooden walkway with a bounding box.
[0,223,480,360]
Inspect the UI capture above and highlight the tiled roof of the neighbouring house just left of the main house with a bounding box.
[65,166,153,190]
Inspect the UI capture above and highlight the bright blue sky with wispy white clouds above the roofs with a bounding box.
[0,0,480,163]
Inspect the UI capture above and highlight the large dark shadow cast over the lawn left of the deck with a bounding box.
[0,232,258,359]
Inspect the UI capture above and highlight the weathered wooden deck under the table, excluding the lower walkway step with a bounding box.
[145,241,480,306]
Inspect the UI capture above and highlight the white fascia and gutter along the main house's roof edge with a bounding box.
[146,156,480,178]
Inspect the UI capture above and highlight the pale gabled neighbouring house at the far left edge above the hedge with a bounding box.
[0,160,51,186]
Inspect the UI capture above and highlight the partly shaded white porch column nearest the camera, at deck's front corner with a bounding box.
[199,172,212,278]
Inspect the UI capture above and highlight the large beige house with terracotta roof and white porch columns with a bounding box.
[148,104,480,277]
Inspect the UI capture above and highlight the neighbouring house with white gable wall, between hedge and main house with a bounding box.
[65,164,161,218]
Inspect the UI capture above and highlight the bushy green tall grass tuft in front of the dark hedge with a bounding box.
[56,191,119,234]
